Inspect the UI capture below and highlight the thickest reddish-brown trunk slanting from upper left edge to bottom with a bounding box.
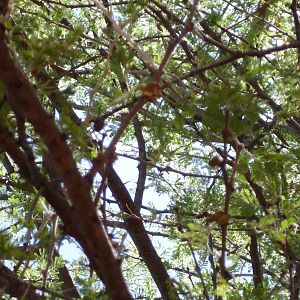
[0,25,131,300]
